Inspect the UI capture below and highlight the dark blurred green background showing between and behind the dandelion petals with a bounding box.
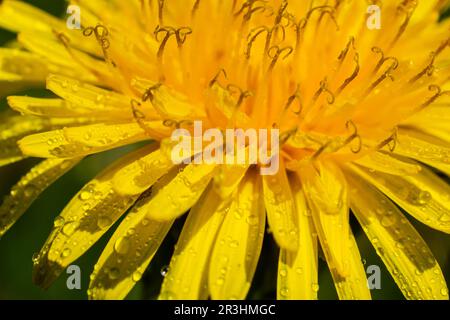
[0,0,450,299]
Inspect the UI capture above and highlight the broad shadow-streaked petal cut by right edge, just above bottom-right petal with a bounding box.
[351,166,450,233]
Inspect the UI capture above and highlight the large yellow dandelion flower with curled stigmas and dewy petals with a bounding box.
[0,0,450,299]
